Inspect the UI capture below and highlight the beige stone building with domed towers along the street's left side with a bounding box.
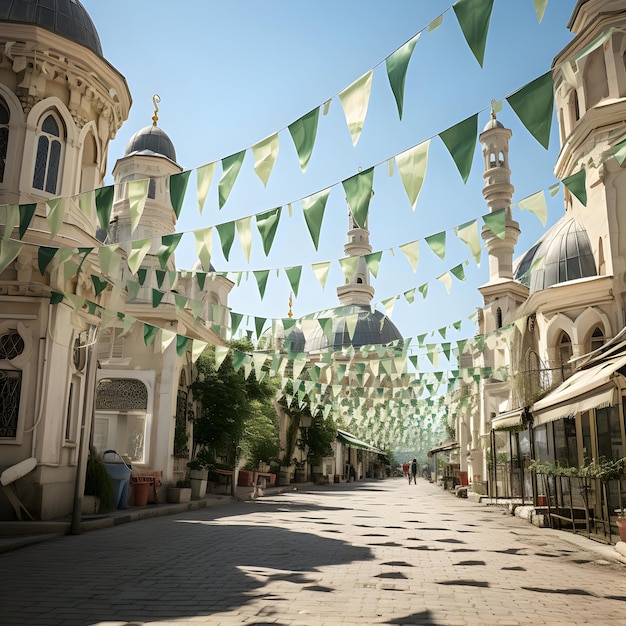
[0,0,233,519]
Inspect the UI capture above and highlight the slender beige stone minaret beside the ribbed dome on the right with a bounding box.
[479,108,520,283]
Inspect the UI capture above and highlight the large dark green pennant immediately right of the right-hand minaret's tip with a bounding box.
[507,71,554,150]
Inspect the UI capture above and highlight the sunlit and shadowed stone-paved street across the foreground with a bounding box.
[0,479,626,626]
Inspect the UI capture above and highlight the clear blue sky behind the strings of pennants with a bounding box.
[83,0,575,360]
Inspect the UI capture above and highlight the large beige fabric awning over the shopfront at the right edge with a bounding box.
[531,355,626,426]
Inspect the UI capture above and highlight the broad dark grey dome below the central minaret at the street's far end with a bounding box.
[305,305,402,352]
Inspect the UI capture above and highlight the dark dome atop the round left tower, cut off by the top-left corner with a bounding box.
[0,0,102,56]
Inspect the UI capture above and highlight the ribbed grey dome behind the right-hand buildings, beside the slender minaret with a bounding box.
[515,216,598,293]
